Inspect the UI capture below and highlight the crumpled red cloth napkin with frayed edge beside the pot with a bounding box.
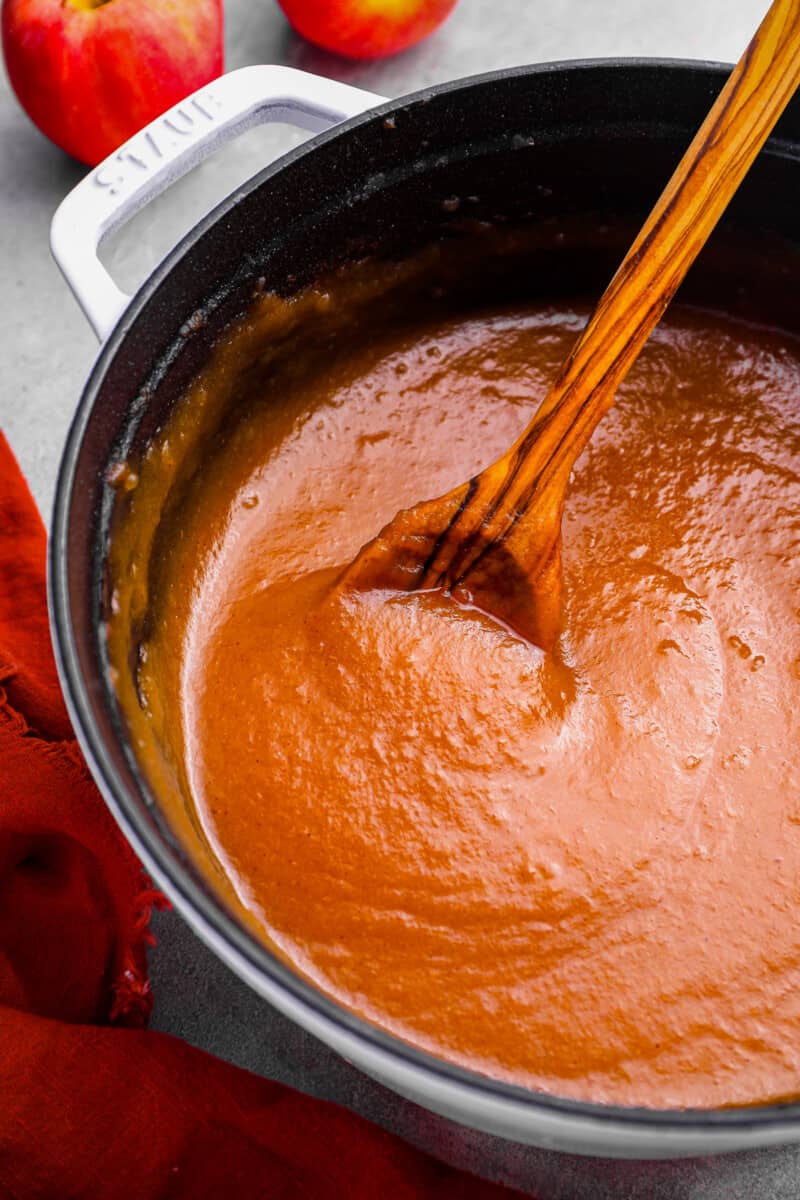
[0,433,525,1200]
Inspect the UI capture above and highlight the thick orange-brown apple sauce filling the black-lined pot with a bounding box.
[115,288,800,1108]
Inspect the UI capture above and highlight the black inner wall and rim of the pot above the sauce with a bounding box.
[53,61,800,1122]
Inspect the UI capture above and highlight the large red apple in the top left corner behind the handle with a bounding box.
[2,0,223,167]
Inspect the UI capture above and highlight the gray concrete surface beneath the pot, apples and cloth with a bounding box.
[0,0,800,1200]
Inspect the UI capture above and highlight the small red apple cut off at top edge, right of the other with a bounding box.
[278,0,457,59]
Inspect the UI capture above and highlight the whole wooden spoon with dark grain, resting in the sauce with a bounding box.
[338,0,800,649]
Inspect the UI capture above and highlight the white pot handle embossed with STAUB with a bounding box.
[50,66,384,341]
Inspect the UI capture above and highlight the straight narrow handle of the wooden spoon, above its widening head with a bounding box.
[512,0,800,468]
